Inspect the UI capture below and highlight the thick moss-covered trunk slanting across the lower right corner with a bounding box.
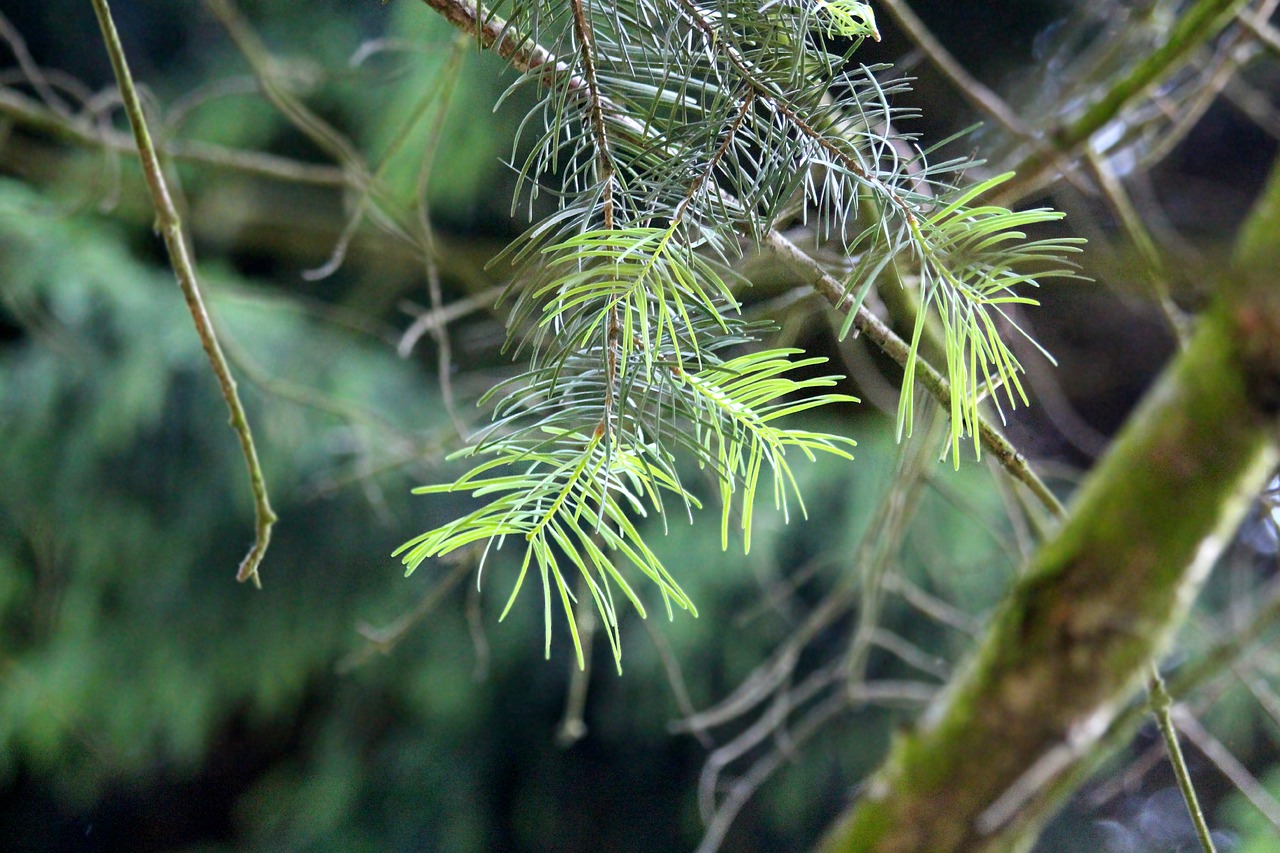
[820,161,1280,853]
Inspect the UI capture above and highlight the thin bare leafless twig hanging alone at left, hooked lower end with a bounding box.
[93,0,276,587]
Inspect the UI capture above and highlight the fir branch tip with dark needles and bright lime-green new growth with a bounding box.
[397,0,1074,661]
